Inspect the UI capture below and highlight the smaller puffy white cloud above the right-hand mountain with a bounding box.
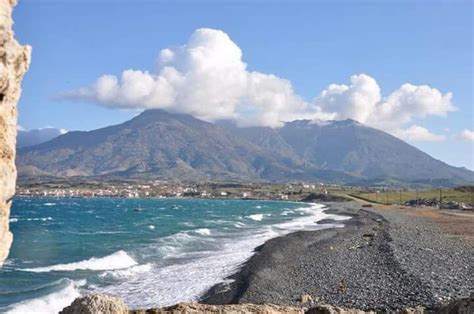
[314,74,456,133]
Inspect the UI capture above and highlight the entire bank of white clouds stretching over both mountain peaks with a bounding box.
[57,28,456,138]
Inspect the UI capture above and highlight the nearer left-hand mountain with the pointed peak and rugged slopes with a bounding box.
[18,110,312,180]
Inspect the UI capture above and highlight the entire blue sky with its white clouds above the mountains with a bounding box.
[14,0,474,169]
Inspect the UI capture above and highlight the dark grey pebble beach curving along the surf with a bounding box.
[201,201,474,311]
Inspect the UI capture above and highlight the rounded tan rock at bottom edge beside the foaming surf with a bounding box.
[59,294,129,314]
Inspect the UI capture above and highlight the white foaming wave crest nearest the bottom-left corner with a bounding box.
[7,280,81,314]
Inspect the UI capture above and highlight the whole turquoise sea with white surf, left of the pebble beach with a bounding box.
[0,198,343,313]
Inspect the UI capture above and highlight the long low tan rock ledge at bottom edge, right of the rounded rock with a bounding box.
[130,303,304,314]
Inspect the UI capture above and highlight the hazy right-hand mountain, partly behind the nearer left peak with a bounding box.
[227,119,474,185]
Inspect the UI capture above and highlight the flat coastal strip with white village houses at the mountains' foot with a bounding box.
[16,180,474,210]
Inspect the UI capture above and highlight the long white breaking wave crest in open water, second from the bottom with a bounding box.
[20,250,138,273]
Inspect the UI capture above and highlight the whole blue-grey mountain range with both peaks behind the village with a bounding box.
[17,109,473,185]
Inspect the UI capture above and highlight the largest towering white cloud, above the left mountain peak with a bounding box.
[61,28,316,126]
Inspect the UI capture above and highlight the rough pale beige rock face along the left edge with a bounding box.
[0,0,31,265]
